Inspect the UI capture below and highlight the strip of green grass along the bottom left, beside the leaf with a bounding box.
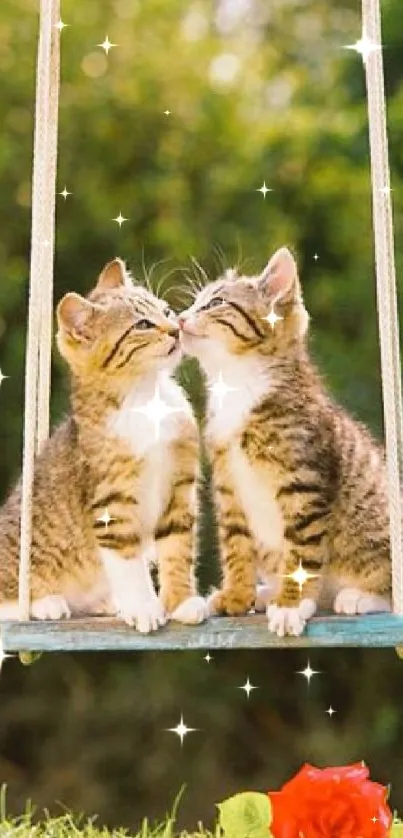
[0,786,220,838]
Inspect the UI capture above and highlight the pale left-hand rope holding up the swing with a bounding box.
[19,0,60,620]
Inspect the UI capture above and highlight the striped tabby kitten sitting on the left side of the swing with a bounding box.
[0,259,205,632]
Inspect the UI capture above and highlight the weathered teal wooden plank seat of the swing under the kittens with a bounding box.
[0,614,403,652]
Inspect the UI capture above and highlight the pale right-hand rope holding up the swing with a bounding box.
[362,0,403,614]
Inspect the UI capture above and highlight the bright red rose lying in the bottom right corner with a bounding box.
[269,763,392,838]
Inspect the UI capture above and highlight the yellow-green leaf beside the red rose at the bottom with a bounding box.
[218,791,272,838]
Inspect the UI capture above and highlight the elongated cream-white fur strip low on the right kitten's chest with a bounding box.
[229,442,284,550]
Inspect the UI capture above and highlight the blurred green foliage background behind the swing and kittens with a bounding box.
[0,0,403,836]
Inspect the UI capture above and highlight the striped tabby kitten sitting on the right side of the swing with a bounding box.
[180,248,391,636]
